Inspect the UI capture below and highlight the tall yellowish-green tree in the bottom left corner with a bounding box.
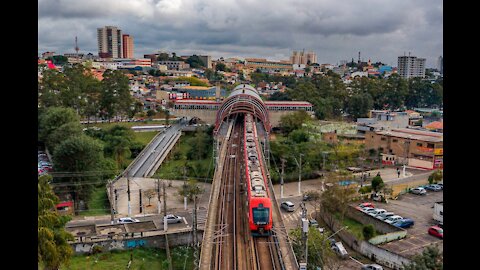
[37,175,74,270]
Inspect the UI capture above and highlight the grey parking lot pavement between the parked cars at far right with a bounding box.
[375,191,443,258]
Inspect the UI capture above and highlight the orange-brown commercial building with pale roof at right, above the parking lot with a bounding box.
[365,128,443,170]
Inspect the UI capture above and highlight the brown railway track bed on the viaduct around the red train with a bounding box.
[210,117,285,270]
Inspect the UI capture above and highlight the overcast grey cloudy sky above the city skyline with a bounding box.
[38,0,443,67]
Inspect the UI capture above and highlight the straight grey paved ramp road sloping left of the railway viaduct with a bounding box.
[129,121,186,177]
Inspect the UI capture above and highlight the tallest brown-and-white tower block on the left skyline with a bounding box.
[97,26,123,58]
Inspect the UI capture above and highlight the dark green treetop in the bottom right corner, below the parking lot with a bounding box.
[403,246,443,270]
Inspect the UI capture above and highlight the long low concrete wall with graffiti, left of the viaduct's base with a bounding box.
[71,230,203,254]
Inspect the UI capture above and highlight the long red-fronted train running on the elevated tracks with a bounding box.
[243,114,272,236]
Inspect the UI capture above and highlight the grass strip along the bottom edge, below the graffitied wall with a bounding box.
[60,247,194,270]
